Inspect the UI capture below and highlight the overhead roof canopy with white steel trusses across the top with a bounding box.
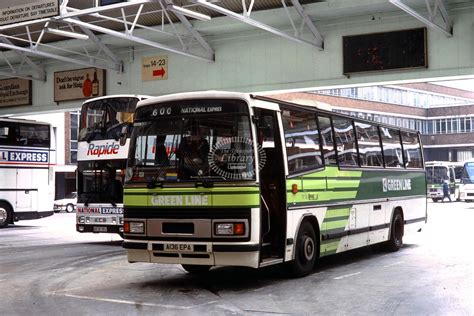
[0,0,460,81]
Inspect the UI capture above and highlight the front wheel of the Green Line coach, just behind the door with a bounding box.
[290,221,319,278]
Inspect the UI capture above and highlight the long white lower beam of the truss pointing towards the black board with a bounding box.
[191,0,323,50]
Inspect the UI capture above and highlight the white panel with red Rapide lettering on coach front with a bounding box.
[77,139,130,161]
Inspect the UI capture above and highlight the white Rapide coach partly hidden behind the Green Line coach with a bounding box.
[76,95,145,235]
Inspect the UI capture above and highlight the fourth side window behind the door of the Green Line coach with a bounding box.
[355,122,383,167]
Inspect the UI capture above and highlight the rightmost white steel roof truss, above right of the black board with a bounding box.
[389,0,453,37]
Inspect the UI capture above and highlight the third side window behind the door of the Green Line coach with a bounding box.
[332,117,359,167]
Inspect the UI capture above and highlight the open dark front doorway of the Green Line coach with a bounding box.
[255,109,286,266]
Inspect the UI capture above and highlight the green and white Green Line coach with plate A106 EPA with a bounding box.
[123,91,427,276]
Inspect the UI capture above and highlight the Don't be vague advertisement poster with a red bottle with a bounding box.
[54,68,105,102]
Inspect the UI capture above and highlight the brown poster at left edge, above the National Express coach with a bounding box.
[0,79,31,107]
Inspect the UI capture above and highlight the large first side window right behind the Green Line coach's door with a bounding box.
[282,107,323,174]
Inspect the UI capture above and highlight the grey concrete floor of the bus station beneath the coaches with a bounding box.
[0,202,474,315]
